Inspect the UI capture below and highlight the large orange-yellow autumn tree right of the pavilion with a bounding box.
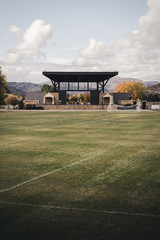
[115,81,147,100]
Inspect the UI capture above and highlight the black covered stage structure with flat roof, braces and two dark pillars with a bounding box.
[43,71,118,105]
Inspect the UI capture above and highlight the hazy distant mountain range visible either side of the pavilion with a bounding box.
[8,77,160,95]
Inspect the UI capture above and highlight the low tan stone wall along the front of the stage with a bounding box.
[42,104,108,110]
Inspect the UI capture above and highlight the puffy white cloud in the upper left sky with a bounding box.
[5,20,52,63]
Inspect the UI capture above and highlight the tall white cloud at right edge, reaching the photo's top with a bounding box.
[114,0,160,80]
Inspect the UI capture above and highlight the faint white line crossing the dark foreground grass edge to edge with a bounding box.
[0,201,160,218]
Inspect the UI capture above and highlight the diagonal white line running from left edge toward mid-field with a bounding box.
[0,153,102,193]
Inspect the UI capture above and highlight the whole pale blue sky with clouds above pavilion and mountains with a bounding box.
[0,0,160,83]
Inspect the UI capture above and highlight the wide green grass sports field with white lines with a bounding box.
[0,111,160,240]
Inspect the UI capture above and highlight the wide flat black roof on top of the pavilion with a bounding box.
[43,71,118,82]
